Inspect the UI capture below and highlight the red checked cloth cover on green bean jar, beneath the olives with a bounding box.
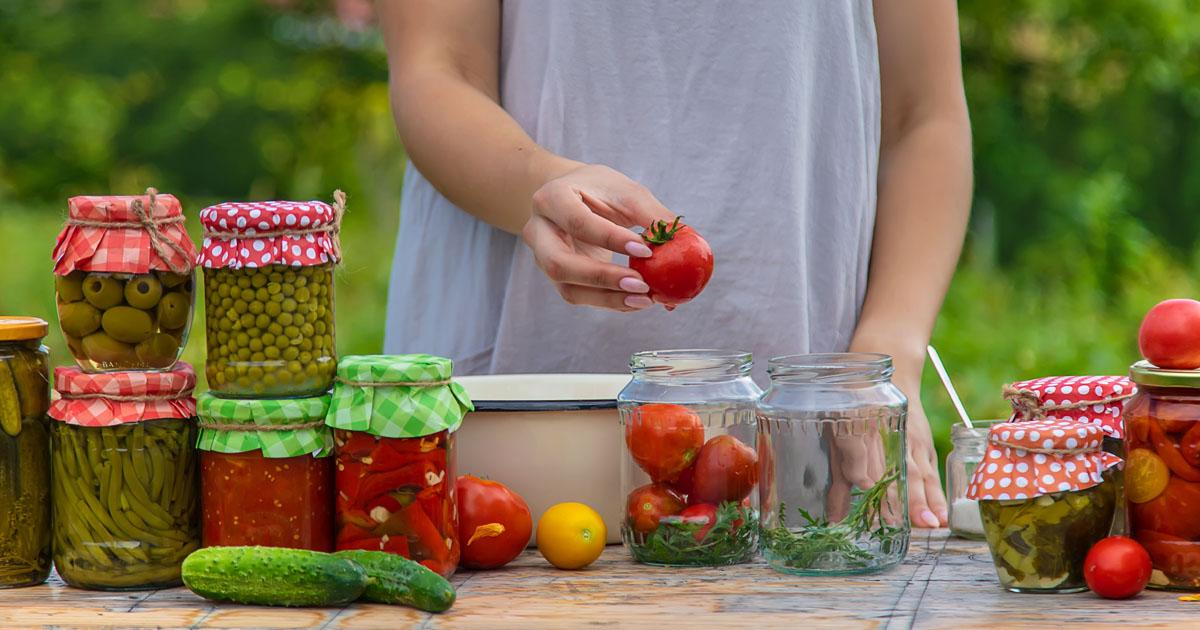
[49,361,196,427]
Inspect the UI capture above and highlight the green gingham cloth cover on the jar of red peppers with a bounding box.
[325,354,475,438]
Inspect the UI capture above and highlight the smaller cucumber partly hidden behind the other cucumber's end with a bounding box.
[334,550,455,612]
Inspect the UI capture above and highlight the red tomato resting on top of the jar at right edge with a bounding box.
[1138,300,1200,370]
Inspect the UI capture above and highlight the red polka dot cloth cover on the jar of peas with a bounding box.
[197,202,340,269]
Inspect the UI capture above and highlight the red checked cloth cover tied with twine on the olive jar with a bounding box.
[53,193,196,276]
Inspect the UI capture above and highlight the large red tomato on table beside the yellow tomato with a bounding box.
[457,475,533,569]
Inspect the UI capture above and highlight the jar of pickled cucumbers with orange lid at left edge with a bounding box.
[0,317,50,588]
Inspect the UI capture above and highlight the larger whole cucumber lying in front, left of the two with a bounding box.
[184,547,367,606]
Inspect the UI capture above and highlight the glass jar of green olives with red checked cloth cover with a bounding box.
[54,188,196,372]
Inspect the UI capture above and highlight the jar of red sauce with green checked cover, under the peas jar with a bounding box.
[197,392,334,551]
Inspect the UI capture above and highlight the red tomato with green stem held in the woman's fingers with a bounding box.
[629,217,713,311]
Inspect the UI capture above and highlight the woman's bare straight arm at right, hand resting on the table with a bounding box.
[851,0,972,527]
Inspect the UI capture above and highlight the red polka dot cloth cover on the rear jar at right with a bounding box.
[1004,376,1138,439]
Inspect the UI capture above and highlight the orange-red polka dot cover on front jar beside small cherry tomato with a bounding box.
[967,420,1122,500]
